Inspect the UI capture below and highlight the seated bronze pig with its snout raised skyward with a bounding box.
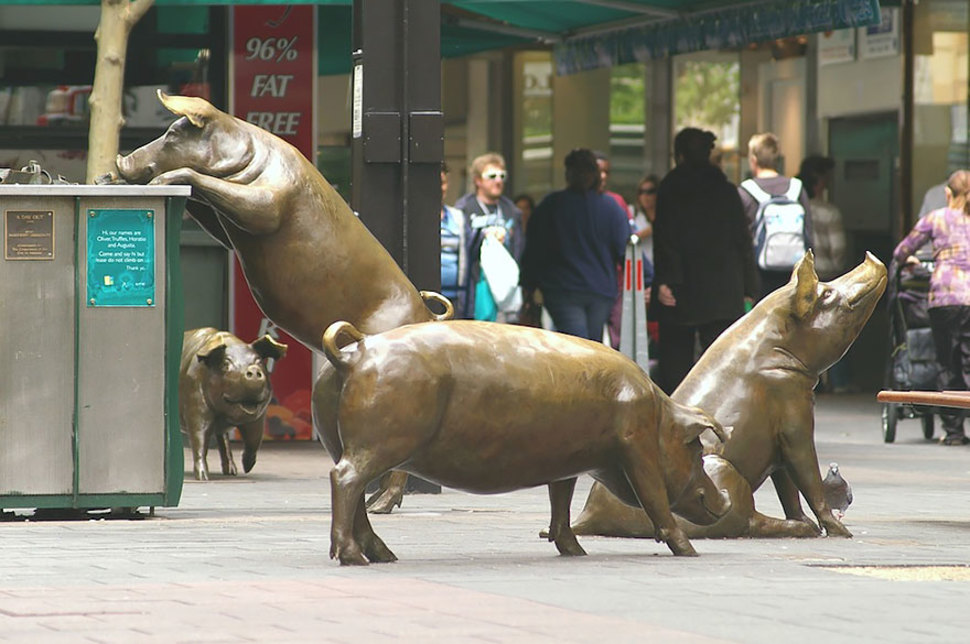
[572,251,887,538]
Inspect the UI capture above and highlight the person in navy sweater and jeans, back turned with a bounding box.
[522,148,630,341]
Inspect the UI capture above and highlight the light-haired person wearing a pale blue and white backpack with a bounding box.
[738,132,812,299]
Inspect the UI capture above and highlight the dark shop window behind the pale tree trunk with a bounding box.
[0,6,225,182]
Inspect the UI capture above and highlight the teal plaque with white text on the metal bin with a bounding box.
[87,209,155,306]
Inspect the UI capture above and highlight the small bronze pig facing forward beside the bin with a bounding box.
[179,327,286,481]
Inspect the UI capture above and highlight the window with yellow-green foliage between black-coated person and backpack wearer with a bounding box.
[673,52,741,182]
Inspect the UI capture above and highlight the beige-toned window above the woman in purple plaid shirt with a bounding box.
[913,0,970,214]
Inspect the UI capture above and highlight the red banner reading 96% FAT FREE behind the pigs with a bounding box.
[230,5,317,439]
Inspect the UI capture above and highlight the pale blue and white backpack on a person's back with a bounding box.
[741,179,808,271]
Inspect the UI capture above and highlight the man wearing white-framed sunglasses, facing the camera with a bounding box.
[455,152,525,322]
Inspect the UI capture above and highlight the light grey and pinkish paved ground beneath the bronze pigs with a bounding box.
[0,394,970,644]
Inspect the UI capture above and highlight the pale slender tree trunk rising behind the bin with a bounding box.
[87,0,155,183]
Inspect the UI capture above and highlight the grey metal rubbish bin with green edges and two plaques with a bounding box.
[0,185,190,509]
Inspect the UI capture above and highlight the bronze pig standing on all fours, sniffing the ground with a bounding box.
[314,321,729,565]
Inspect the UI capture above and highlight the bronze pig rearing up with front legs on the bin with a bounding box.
[116,92,452,512]
